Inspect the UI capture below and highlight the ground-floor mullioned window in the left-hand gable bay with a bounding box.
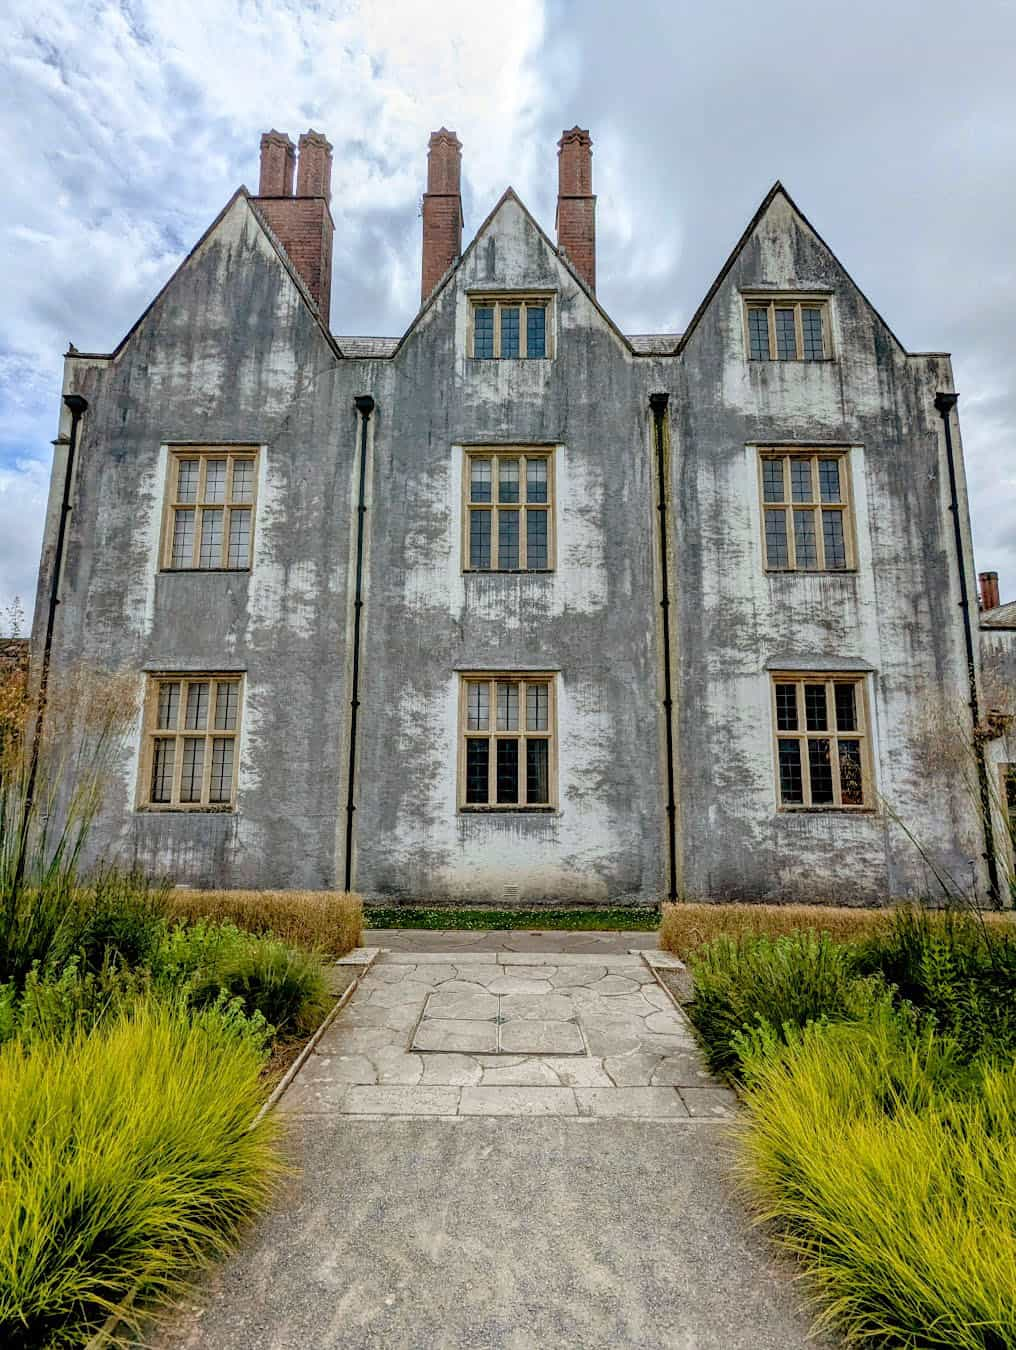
[139,674,243,811]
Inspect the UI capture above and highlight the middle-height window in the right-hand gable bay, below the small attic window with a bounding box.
[761,450,854,572]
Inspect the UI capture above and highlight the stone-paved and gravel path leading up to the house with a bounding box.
[150,933,820,1350]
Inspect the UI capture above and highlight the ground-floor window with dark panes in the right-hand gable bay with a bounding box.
[772,674,872,810]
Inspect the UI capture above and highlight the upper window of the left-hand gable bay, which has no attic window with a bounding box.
[162,447,258,570]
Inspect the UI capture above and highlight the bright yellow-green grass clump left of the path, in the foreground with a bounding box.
[0,999,278,1350]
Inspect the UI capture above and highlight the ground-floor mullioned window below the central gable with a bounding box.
[459,672,557,811]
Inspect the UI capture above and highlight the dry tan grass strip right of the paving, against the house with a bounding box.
[660,903,1013,957]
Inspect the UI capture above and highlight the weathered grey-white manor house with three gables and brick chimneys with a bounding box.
[32,127,1016,905]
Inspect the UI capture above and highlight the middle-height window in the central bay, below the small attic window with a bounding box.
[464,448,553,572]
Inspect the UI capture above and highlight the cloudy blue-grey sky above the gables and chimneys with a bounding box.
[0,0,1016,612]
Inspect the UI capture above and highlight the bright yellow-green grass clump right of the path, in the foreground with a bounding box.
[742,1006,1016,1350]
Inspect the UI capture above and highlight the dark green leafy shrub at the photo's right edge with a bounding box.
[858,907,1016,1056]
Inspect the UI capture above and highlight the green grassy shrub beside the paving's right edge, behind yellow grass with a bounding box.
[687,933,881,1072]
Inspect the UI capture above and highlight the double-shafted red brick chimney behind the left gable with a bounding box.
[254,131,335,327]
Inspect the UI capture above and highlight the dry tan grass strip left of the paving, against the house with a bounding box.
[161,890,363,956]
